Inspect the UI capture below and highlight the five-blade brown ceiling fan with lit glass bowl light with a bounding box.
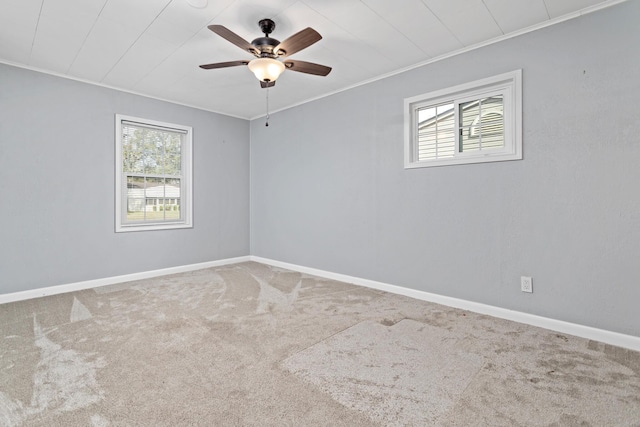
[200,19,331,88]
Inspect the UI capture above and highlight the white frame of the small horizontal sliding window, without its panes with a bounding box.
[404,70,522,169]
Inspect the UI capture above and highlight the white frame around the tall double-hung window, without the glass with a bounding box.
[115,114,193,233]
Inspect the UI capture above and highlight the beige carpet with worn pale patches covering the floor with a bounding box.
[0,263,640,426]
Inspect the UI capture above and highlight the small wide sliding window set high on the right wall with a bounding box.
[404,70,522,168]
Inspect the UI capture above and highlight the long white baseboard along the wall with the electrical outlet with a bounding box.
[249,255,640,351]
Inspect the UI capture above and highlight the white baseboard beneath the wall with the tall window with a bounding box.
[0,255,251,304]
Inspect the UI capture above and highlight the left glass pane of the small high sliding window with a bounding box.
[418,103,455,161]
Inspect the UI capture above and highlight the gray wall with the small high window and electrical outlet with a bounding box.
[251,1,640,336]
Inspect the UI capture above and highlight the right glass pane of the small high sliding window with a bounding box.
[459,95,504,152]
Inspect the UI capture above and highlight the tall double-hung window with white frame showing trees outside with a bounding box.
[116,114,193,232]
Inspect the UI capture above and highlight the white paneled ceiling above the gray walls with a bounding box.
[0,0,620,118]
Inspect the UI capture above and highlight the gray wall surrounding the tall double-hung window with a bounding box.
[0,64,249,294]
